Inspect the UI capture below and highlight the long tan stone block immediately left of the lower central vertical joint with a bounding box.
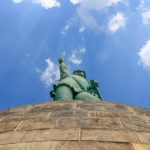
[22,129,79,142]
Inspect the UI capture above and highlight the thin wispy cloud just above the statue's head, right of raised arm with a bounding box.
[69,48,86,65]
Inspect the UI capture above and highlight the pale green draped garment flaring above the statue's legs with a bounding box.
[54,75,89,93]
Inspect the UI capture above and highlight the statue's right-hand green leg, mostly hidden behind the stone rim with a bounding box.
[74,92,100,100]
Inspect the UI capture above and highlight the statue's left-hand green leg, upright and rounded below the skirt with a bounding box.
[55,85,73,101]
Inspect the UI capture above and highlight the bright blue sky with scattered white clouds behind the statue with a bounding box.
[0,0,150,110]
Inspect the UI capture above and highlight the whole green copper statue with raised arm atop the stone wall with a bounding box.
[50,57,102,101]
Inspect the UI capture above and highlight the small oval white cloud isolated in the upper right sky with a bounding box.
[108,12,126,33]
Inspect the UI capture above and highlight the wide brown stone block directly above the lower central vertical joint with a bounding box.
[56,118,123,129]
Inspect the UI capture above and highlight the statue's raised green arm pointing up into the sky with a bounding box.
[58,56,69,79]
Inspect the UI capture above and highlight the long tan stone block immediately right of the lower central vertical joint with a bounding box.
[81,129,138,143]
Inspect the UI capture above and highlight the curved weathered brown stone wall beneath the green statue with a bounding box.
[0,101,150,150]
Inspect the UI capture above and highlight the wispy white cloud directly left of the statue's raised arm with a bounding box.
[40,58,59,86]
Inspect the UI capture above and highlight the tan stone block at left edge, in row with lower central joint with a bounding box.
[0,132,24,144]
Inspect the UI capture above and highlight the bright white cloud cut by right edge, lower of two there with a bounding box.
[138,40,150,69]
